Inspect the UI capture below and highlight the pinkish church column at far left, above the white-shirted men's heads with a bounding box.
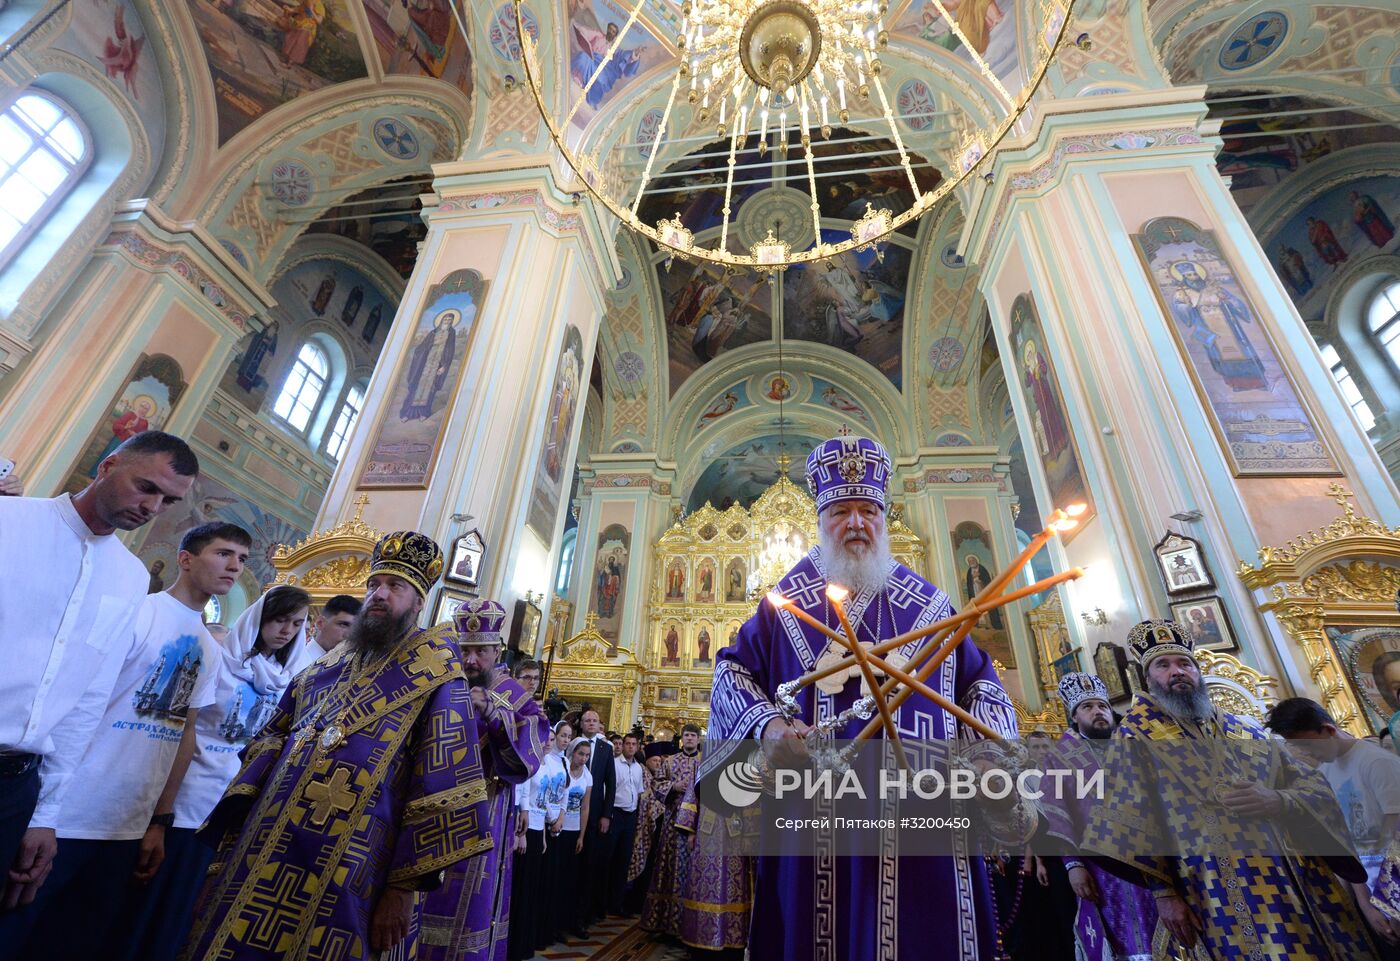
[0,202,273,496]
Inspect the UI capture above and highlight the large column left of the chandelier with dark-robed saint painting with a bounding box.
[318,158,617,621]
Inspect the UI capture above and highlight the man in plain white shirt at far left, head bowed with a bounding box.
[0,430,199,909]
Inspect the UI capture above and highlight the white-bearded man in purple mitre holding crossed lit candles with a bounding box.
[700,436,1019,961]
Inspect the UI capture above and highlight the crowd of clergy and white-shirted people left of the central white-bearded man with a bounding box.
[0,431,733,961]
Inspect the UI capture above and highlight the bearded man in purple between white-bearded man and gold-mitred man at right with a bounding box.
[1040,671,1158,961]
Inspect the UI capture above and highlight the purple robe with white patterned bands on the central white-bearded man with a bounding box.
[706,549,1016,961]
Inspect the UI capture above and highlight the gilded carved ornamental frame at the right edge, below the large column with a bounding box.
[1239,483,1400,737]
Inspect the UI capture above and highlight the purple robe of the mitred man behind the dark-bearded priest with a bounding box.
[419,671,549,961]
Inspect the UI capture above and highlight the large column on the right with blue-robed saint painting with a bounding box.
[967,88,1400,691]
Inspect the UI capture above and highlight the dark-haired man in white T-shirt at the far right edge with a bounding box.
[1268,698,1400,961]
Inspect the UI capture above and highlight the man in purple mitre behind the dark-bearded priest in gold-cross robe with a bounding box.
[419,600,550,961]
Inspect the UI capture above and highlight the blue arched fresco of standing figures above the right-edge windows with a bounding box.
[1264,177,1400,324]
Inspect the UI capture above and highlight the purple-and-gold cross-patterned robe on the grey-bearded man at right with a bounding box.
[1082,693,1375,961]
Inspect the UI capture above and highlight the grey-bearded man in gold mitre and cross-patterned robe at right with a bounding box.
[1082,621,1375,961]
